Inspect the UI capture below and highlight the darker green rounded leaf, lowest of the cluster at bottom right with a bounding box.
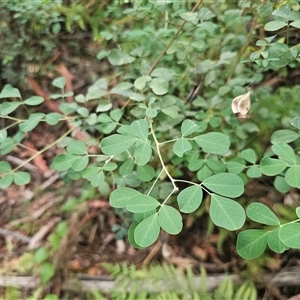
[236,229,269,259]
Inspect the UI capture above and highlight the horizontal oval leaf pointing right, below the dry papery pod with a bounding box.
[194,132,230,154]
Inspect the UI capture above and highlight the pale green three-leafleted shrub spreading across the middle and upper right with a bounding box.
[0,1,300,259]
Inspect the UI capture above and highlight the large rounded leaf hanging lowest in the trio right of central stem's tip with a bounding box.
[209,194,246,230]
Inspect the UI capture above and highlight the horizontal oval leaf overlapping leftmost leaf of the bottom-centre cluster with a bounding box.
[126,194,160,213]
